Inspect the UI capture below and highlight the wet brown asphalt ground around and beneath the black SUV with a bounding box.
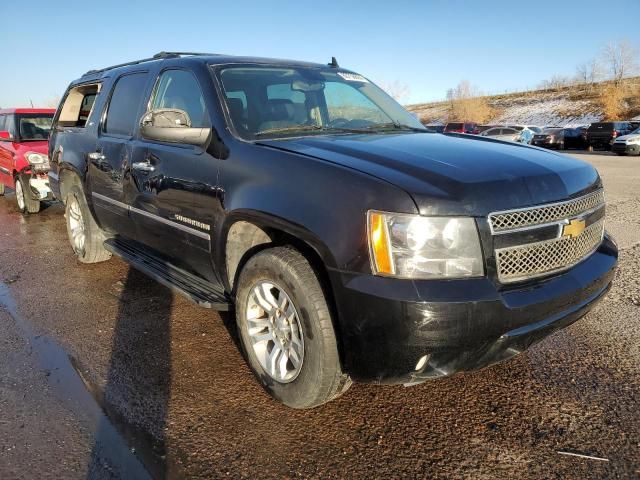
[0,154,640,480]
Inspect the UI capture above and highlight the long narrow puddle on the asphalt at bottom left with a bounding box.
[0,282,160,479]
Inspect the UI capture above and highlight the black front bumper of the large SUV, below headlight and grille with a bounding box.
[329,236,618,384]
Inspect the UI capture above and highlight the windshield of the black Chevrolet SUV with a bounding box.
[217,65,428,140]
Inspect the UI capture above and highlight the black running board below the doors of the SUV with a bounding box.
[104,238,232,312]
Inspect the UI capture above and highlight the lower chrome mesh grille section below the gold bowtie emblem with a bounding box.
[496,220,604,283]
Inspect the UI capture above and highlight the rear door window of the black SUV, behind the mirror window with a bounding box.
[104,72,147,137]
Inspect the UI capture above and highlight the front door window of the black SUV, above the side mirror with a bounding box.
[151,70,209,128]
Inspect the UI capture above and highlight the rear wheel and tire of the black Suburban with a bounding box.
[64,183,111,263]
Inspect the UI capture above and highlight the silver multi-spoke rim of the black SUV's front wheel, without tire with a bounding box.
[246,281,304,383]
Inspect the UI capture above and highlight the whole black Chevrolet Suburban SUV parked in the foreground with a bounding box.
[49,53,617,408]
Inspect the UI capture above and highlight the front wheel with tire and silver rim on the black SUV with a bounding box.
[236,247,351,408]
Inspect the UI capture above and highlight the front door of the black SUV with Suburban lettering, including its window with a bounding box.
[131,68,218,282]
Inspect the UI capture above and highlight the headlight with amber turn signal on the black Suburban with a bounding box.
[367,210,484,279]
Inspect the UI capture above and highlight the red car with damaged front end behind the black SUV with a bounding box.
[0,108,55,213]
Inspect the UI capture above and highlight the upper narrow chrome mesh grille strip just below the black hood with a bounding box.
[489,190,604,233]
